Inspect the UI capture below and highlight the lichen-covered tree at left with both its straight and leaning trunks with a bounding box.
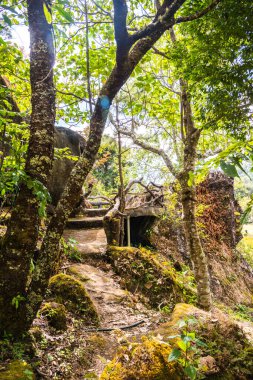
[0,0,222,335]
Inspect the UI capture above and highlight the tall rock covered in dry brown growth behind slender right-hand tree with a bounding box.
[150,172,253,306]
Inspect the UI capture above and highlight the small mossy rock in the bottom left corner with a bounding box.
[0,360,35,380]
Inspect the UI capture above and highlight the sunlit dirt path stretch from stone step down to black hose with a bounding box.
[64,229,160,336]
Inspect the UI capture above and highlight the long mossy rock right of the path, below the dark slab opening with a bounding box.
[107,247,196,307]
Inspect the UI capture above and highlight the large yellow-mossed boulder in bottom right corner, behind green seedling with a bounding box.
[100,303,253,380]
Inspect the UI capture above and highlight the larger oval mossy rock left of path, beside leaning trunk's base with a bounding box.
[49,273,99,325]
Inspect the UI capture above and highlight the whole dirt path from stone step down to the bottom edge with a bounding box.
[40,229,165,380]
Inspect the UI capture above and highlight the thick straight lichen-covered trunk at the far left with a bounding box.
[0,0,55,335]
